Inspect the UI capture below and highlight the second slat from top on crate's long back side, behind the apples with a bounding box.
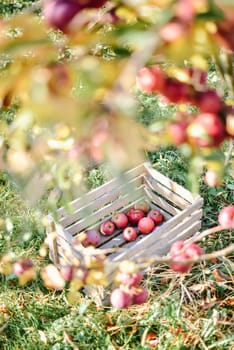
[67,185,143,235]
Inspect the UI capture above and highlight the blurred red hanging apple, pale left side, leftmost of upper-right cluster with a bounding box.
[137,66,165,92]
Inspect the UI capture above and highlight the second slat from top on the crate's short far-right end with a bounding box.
[144,176,190,209]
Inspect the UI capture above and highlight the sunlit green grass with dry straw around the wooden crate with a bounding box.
[0,0,234,350]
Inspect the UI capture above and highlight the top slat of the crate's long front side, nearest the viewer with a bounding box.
[110,199,203,259]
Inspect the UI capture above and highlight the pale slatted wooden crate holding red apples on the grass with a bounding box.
[47,163,203,296]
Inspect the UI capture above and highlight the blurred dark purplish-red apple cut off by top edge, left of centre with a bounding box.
[43,0,81,32]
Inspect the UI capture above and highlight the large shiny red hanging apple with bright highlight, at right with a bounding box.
[187,113,226,147]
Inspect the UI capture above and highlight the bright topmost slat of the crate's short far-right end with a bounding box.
[144,162,198,203]
